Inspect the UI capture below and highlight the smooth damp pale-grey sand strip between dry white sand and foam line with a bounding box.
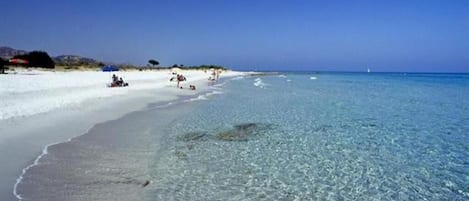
[0,69,247,200]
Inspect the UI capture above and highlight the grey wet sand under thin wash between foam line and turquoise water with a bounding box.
[17,96,197,201]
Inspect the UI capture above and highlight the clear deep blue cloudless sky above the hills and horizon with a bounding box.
[0,0,469,72]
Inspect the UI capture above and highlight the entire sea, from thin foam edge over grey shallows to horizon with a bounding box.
[15,72,469,201]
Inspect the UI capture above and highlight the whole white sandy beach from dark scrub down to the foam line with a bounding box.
[0,70,243,200]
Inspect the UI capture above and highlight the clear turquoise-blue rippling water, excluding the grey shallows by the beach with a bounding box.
[146,73,469,200]
